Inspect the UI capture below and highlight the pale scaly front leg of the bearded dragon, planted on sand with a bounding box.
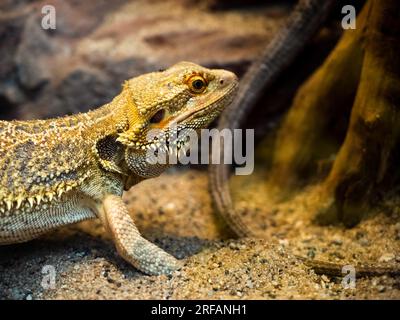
[100,195,181,275]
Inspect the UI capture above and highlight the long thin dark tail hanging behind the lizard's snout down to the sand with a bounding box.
[209,0,334,237]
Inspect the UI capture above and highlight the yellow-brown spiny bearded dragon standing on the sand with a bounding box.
[0,62,238,275]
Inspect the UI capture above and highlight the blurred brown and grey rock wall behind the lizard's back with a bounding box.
[0,0,290,119]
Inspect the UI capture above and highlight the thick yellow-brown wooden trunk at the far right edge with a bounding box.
[325,0,400,225]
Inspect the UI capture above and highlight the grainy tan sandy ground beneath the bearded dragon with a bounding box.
[0,169,400,299]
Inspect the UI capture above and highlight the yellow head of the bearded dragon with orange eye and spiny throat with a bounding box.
[117,62,238,178]
